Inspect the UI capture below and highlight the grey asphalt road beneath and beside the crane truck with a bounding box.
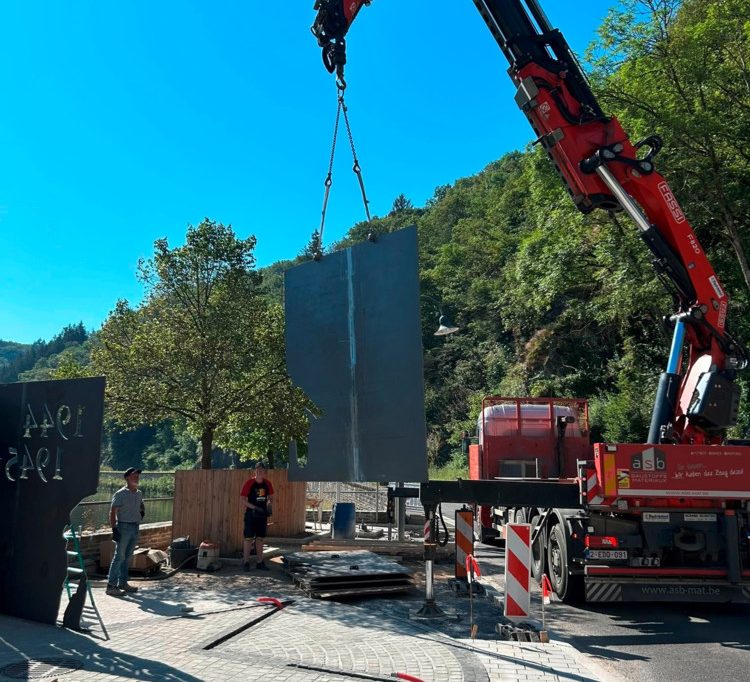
[475,544,750,682]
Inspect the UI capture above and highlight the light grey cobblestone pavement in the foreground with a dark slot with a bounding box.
[0,564,597,682]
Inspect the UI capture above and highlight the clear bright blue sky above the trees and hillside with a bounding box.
[0,0,616,342]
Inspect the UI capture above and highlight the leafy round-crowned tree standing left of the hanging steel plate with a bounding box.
[91,218,314,469]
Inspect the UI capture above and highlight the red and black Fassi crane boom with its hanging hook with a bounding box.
[312,0,747,444]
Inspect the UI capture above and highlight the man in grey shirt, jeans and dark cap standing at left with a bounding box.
[107,467,145,597]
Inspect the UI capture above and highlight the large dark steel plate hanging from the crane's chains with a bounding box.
[284,226,427,481]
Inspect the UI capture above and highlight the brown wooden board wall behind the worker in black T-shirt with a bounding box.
[172,469,305,556]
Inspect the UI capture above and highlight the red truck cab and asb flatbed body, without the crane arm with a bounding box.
[469,397,750,603]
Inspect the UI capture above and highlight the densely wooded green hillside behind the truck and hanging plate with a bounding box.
[7,0,750,467]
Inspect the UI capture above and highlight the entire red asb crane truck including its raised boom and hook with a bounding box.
[312,0,750,602]
